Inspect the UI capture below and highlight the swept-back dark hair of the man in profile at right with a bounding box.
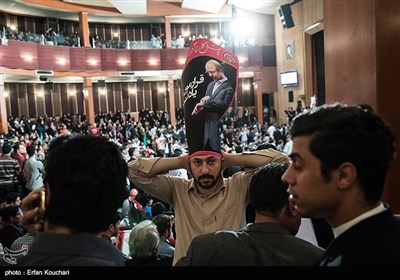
[290,103,395,202]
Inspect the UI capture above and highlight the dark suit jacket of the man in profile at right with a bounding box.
[321,208,400,267]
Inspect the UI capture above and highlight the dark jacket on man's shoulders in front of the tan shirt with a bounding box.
[176,223,324,266]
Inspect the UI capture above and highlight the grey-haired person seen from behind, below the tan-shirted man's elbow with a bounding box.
[125,220,172,266]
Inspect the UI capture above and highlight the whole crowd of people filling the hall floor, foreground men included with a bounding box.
[0,104,400,266]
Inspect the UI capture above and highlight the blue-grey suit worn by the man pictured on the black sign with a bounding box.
[204,80,234,152]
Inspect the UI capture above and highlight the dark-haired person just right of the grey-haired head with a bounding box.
[153,214,175,259]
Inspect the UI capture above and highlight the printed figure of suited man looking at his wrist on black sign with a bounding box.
[192,59,234,152]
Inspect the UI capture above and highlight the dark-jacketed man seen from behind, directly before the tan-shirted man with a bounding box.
[176,163,323,266]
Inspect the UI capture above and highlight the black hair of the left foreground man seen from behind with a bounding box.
[44,135,128,233]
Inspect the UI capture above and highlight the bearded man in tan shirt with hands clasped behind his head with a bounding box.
[128,149,287,263]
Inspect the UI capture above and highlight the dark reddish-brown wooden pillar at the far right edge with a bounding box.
[375,0,400,213]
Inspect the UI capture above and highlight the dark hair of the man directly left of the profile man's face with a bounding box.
[249,163,289,213]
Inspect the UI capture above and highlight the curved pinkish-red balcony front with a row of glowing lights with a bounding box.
[0,40,276,83]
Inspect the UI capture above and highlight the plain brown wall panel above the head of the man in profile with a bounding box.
[324,0,377,108]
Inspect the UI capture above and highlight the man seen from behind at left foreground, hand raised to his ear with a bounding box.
[18,136,127,266]
